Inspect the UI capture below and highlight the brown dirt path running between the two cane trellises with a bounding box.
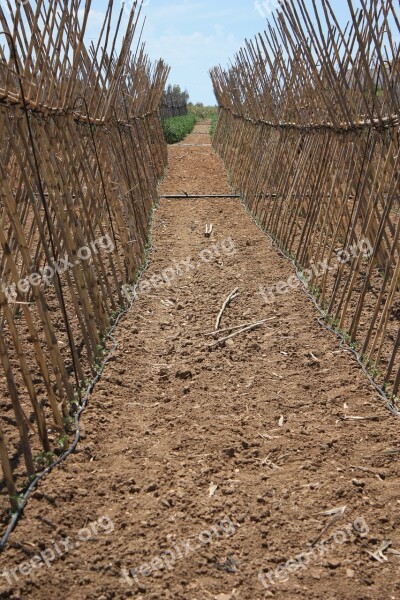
[0,124,400,600]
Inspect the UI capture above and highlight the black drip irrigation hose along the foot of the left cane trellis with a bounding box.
[0,260,149,553]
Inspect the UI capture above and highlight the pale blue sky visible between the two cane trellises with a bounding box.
[88,0,358,104]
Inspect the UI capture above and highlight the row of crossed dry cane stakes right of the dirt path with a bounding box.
[211,0,400,398]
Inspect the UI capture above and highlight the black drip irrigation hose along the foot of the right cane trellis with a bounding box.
[238,197,400,417]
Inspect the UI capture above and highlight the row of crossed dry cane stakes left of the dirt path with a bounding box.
[0,0,169,523]
